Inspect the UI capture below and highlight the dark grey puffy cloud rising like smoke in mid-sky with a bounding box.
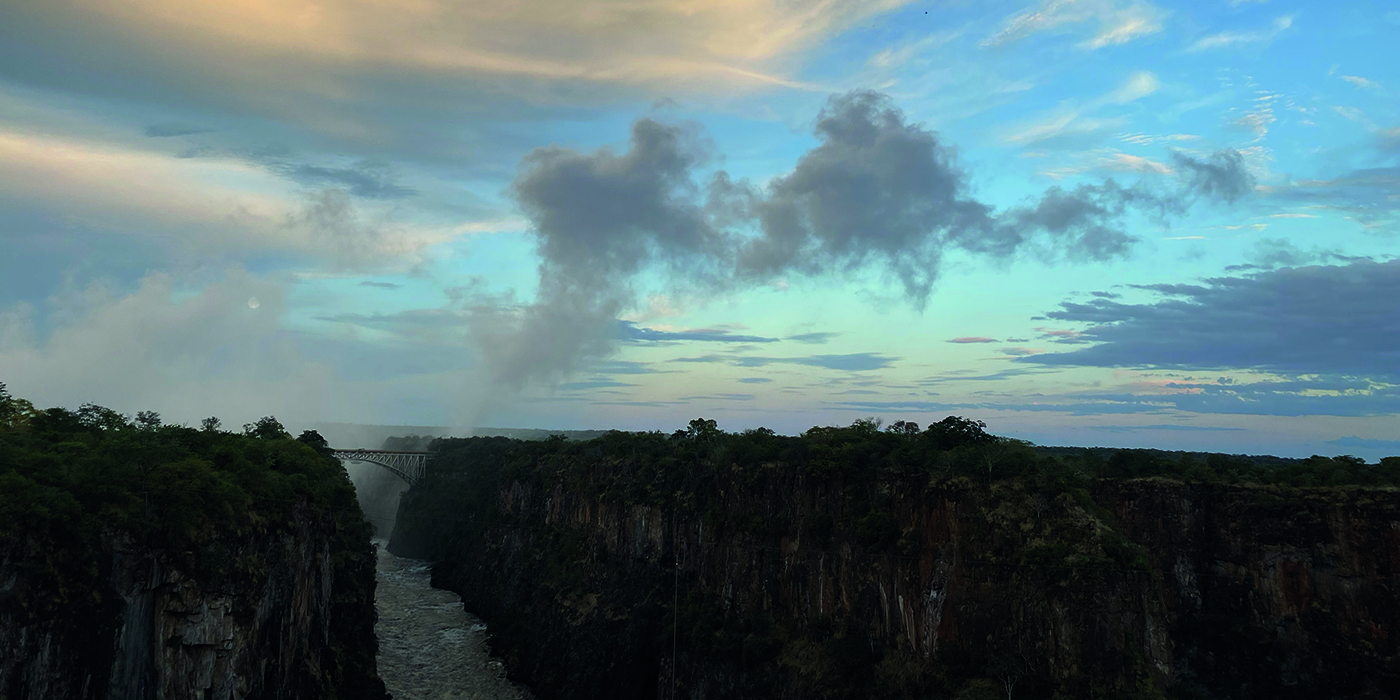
[464,91,1245,403]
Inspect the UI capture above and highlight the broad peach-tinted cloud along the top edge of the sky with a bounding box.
[10,0,904,99]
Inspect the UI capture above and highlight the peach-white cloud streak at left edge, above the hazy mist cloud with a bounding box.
[0,127,454,269]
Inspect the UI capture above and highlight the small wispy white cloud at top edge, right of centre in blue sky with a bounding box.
[981,0,1165,50]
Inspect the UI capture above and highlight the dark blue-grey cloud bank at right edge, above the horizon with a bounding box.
[1018,260,1400,379]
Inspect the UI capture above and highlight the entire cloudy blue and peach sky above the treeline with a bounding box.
[0,0,1400,459]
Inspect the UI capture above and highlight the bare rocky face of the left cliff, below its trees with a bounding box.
[0,508,386,700]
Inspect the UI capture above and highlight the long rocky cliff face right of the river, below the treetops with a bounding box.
[392,436,1400,699]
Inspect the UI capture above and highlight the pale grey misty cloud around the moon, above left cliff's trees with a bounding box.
[0,269,364,427]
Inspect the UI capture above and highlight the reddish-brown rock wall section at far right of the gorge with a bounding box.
[1096,479,1400,697]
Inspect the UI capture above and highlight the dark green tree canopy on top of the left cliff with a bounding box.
[0,384,370,606]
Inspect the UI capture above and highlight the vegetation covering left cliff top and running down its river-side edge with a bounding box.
[0,384,382,699]
